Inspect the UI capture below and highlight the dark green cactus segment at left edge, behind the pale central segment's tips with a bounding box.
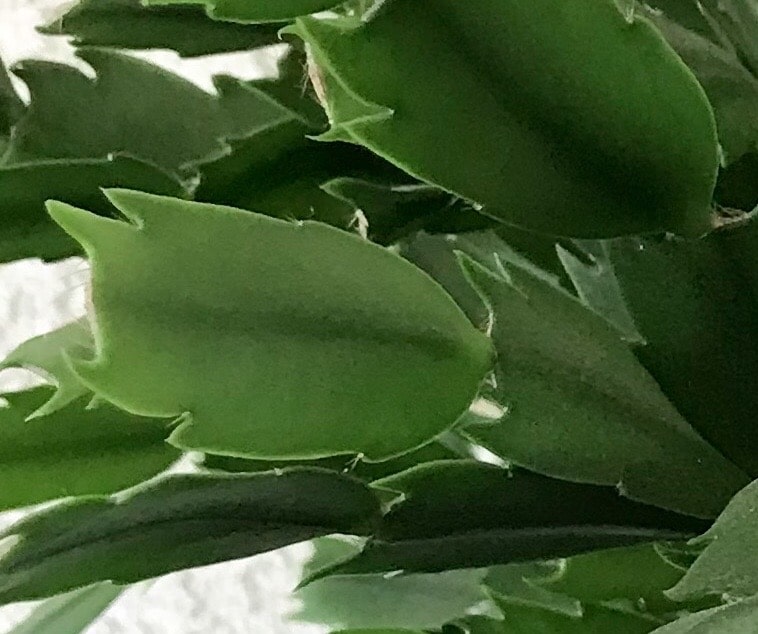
[0,155,189,262]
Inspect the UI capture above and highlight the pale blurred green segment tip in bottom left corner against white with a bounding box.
[7,583,124,634]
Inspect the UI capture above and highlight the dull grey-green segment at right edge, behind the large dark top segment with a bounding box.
[652,11,758,164]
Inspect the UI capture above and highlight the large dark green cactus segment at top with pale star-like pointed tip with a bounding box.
[290,0,718,237]
